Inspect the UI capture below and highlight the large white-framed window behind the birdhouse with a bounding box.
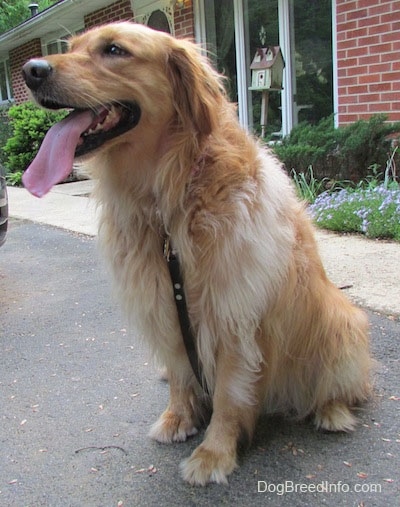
[194,0,333,138]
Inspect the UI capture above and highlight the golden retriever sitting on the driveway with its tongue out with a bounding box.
[23,22,371,485]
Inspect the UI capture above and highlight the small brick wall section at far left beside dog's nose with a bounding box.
[10,39,42,104]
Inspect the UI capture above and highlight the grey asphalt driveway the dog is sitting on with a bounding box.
[0,221,400,507]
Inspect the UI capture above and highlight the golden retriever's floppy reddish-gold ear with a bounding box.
[168,41,224,135]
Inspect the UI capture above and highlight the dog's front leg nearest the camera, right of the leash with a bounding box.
[181,350,260,486]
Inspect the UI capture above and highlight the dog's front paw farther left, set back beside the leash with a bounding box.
[149,410,197,444]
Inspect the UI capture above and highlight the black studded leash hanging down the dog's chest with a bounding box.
[164,236,208,394]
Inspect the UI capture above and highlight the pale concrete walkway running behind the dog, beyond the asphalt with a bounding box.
[8,180,400,316]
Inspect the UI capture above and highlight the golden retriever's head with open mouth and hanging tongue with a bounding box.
[23,22,223,195]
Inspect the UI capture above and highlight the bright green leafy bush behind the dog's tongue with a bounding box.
[3,102,66,184]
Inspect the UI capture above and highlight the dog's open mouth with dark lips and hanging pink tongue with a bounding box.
[22,102,141,197]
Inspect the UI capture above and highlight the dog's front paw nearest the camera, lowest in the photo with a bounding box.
[181,445,237,486]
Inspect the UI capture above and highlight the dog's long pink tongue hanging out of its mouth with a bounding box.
[22,111,93,197]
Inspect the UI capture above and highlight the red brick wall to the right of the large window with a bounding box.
[336,0,400,125]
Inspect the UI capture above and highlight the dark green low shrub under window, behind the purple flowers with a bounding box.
[274,115,400,182]
